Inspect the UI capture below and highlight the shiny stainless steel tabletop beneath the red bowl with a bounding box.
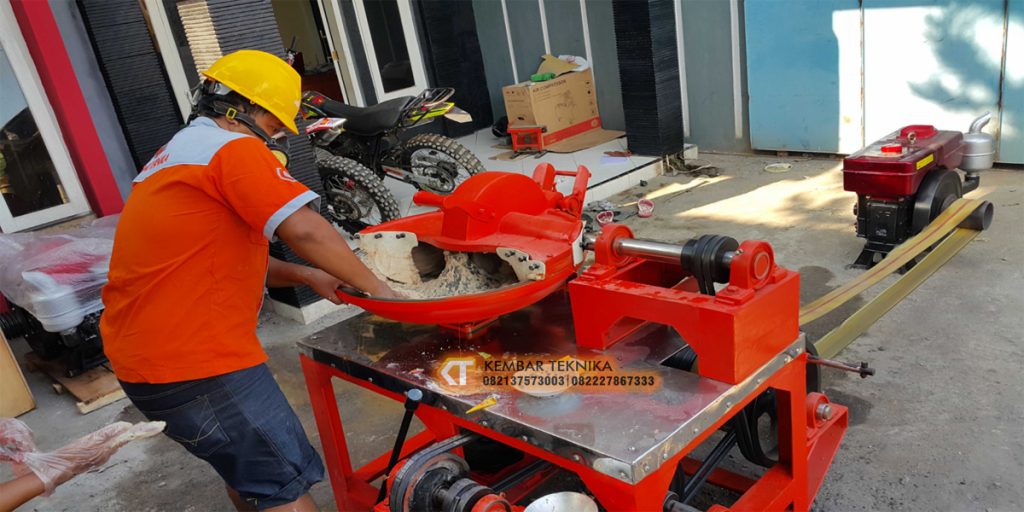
[299,292,804,483]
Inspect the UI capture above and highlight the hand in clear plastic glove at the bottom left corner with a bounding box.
[0,418,165,496]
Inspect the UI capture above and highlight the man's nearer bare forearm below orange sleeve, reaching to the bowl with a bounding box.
[267,208,397,298]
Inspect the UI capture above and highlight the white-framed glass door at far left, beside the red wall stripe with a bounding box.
[0,0,89,232]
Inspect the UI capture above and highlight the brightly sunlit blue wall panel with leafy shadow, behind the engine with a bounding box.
[863,0,1005,142]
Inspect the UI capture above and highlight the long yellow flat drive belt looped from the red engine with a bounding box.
[800,198,984,358]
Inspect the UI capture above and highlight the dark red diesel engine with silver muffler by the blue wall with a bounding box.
[843,114,994,268]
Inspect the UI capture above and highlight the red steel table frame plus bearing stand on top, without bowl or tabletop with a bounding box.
[301,217,848,512]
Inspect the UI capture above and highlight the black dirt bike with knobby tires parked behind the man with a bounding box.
[300,88,484,233]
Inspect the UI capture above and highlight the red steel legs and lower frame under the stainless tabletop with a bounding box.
[300,346,848,512]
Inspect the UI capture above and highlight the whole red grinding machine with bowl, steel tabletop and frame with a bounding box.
[299,165,848,512]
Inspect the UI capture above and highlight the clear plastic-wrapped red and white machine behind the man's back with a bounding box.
[0,215,119,333]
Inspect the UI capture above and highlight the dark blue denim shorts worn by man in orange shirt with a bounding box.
[121,365,324,510]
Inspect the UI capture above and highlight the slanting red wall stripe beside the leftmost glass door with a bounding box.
[10,0,124,217]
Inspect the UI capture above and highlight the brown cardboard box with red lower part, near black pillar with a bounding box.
[502,69,624,153]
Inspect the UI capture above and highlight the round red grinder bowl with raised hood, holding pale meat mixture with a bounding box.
[338,164,590,330]
